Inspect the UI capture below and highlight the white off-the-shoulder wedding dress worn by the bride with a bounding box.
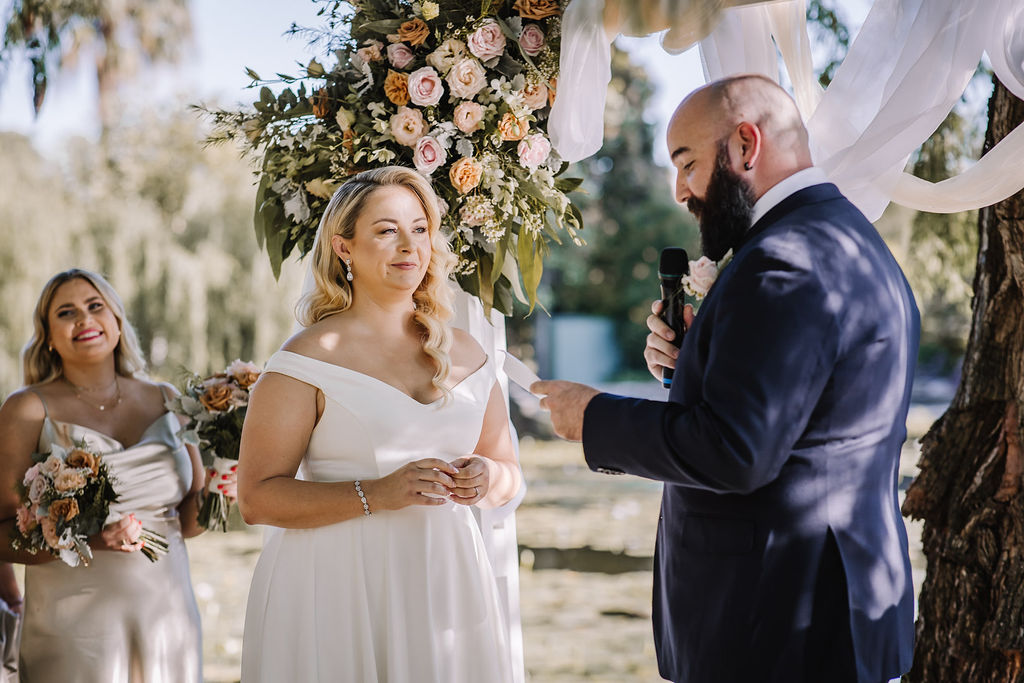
[242,351,512,683]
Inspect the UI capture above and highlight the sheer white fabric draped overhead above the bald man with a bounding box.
[549,0,1024,220]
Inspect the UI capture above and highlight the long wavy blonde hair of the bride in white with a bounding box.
[296,166,458,395]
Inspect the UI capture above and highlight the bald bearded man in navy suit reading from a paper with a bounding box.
[531,76,920,683]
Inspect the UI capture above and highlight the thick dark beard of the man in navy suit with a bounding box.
[686,140,757,261]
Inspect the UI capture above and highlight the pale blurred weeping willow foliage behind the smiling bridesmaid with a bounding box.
[0,115,301,394]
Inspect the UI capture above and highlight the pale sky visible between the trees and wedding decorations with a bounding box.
[0,0,703,165]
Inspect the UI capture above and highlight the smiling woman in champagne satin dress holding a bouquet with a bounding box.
[0,269,233,683]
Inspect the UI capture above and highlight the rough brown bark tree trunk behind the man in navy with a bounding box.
[903,76,1024,683]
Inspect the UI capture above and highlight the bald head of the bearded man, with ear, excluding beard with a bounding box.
[668,74,811,197]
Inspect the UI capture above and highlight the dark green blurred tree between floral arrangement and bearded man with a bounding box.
[548,49,699,375]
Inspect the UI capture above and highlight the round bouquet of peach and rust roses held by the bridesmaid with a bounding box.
[10,444,167,567]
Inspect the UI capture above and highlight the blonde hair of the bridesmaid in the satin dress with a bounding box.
[22,268,145,386]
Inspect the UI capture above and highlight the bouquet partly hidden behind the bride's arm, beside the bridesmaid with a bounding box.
[166,360,260,531]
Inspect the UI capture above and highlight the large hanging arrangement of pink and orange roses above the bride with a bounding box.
[203,0,583,313]
